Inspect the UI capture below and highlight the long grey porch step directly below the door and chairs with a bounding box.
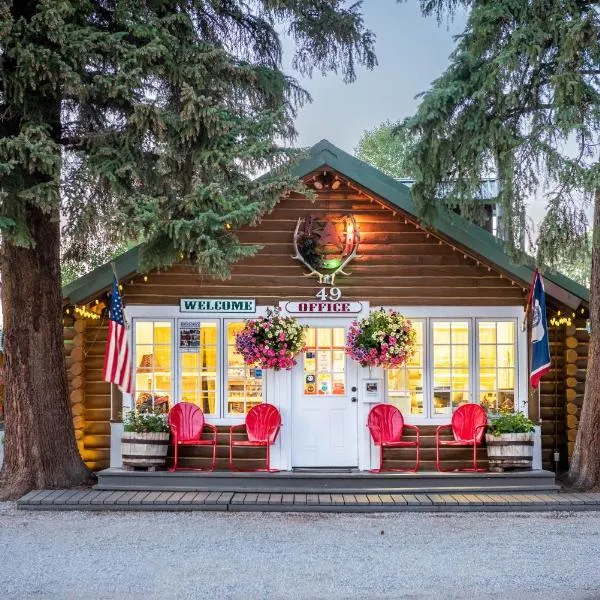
[95,469,559,494]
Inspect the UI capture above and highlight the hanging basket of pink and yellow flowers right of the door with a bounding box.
[346,308,417,369]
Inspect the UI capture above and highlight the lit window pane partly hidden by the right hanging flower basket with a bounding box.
[387,321,424,415]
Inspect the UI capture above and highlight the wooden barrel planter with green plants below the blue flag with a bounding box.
[485,412,534,472]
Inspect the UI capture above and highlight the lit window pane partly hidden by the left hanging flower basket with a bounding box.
[226,321,263,416]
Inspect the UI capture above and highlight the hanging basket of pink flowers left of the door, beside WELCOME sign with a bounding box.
[235,308,307,371]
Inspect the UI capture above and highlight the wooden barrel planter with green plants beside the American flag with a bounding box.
[121,409,170,469]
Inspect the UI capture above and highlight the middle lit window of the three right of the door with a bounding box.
[432,321,470,416]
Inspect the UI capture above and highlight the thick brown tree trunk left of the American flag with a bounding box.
[0,205,92,499]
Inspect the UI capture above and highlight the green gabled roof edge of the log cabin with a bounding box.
[63,140,589,308]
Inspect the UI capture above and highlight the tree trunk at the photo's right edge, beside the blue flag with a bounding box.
[569,190,600,490]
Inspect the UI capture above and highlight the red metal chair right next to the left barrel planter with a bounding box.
[168,402,217,471]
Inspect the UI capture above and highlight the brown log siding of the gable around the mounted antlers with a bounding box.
[123,192,524,306]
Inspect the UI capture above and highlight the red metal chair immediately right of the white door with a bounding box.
[367,404,421,473]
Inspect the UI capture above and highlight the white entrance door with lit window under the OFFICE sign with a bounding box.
[292,320,358,467]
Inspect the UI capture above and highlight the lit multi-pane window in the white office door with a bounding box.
[303,327,346,396]
